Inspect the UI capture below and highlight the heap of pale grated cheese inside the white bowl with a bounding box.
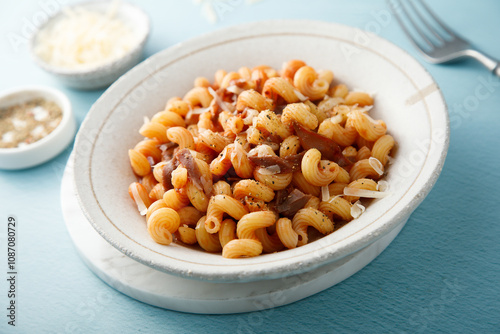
[34,1,139,69]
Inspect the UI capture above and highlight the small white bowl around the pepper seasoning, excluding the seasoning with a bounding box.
[0,86,76,169]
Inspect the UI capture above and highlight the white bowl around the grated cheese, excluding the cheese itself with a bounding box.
[31,1,150,89]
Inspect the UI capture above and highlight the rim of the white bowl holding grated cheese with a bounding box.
[29,0,151,77]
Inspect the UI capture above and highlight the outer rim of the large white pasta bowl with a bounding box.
[71,20,450,282]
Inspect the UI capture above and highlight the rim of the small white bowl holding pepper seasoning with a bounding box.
[0,85,74,156]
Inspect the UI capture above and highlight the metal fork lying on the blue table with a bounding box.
[387,0,500,77]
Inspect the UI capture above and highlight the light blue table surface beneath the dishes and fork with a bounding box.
[0,0,500,333]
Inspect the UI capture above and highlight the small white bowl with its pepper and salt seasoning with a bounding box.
[0,86,76,170]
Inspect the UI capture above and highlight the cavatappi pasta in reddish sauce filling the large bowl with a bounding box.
[128,60,396,258]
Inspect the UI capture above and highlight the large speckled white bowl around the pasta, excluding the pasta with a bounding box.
[75,20,449,282]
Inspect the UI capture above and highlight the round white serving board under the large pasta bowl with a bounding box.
[61,157,405,314]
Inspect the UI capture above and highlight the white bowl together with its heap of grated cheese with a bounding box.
[31,1,150,89]
